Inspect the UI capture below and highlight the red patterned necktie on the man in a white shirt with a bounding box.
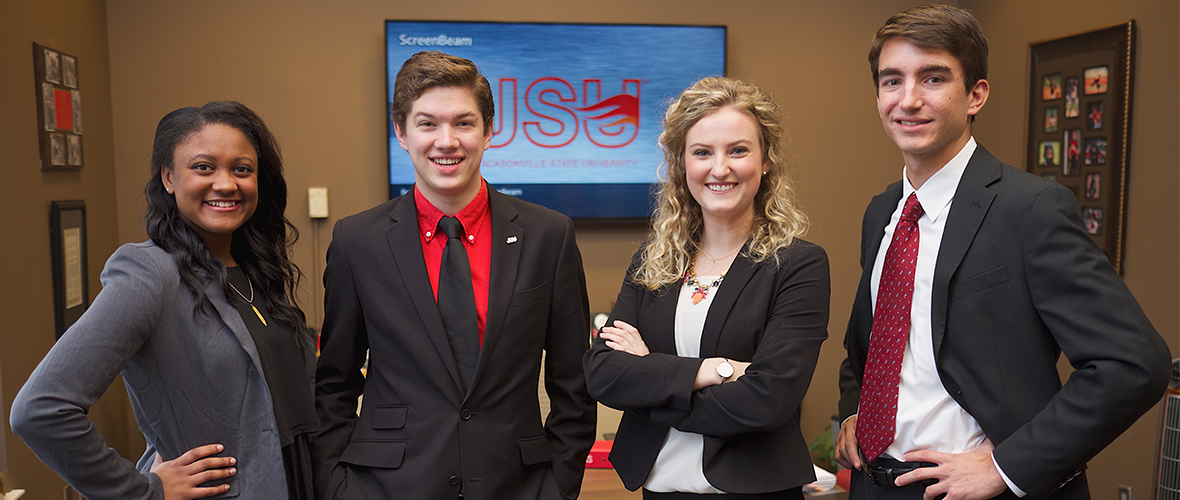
[857,193,923,462]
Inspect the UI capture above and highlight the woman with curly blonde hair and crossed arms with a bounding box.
[583,78,830,499]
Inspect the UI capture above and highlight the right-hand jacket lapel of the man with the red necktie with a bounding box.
[930,146,1001,358]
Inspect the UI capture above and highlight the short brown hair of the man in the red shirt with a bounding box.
[389,51,496,133]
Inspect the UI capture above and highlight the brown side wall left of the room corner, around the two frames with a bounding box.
[0,0,143,500]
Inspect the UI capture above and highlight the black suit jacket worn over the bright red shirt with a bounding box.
[313,189,596,500]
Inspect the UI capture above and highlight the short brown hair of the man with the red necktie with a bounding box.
[868,4,988,92]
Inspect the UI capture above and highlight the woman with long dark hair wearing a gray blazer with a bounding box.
[11,101,319,500]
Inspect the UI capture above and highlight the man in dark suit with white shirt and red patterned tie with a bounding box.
[837,6,1171,500]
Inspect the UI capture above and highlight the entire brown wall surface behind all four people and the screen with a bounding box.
[0,0,1180,500]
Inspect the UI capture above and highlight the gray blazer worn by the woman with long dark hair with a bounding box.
[11,242,315,500]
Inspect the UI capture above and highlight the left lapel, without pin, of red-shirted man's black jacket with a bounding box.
[385,196,466,393]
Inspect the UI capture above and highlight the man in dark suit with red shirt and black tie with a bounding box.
[313,52,596,500]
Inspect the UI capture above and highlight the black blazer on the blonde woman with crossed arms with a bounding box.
[583,239,831,493]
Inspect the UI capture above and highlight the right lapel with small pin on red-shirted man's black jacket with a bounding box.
[471,191,527,387]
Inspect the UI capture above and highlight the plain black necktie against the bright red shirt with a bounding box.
[438,217,479,389]
